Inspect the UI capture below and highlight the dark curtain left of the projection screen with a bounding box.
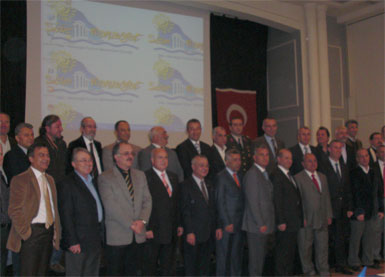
[0,0,27,133]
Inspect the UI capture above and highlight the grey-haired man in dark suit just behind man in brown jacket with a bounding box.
[4,123,34,183]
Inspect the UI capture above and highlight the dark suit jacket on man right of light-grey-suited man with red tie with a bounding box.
[318,158,353,219]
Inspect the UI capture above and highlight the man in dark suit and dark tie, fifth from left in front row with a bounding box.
[180,155,222,276]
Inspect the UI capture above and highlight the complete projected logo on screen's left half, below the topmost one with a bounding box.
[45,51,143,97]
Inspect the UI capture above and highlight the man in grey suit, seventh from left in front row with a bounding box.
[242,145,275,276]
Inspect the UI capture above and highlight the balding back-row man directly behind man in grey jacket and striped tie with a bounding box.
[102,120,142,170]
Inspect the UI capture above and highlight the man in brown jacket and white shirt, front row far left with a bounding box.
[7,143,60,276]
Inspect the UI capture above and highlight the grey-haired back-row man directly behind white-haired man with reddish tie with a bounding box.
[133,126,183,182]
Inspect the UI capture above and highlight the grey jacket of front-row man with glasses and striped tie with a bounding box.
[98,166,152,246]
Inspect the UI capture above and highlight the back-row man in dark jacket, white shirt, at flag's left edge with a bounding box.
[210,126,227,178]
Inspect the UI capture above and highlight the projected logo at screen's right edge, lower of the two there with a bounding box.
[150,59,203,101]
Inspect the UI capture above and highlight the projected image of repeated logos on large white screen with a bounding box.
[41,1,204,131]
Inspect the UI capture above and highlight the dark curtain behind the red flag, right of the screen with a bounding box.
[210,14,267,134]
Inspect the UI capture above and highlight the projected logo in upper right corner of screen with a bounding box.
[148,14,203,56]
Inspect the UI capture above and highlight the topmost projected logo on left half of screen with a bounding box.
[44,1,143,49]
